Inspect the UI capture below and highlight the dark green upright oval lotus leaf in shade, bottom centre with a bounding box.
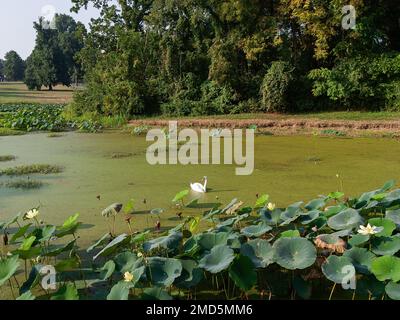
[229,255,257,291]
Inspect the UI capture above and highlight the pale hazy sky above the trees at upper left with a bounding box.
[0,0,98,59]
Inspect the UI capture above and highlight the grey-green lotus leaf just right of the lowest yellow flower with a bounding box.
[147,257,182,287]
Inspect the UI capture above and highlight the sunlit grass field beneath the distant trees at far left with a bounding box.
[0,82,74,104]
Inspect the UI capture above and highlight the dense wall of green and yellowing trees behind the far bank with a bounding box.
[67,0,400,115]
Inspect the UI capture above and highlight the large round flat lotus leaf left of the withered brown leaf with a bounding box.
[273,238,316,270]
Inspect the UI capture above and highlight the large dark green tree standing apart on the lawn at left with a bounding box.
[25,14,86,90]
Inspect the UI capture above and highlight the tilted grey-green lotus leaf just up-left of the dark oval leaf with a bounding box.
[199,245,235,273]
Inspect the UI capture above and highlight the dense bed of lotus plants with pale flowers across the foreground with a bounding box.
[0,181,400,300]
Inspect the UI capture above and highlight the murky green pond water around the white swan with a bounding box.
[0,132,400,245]
